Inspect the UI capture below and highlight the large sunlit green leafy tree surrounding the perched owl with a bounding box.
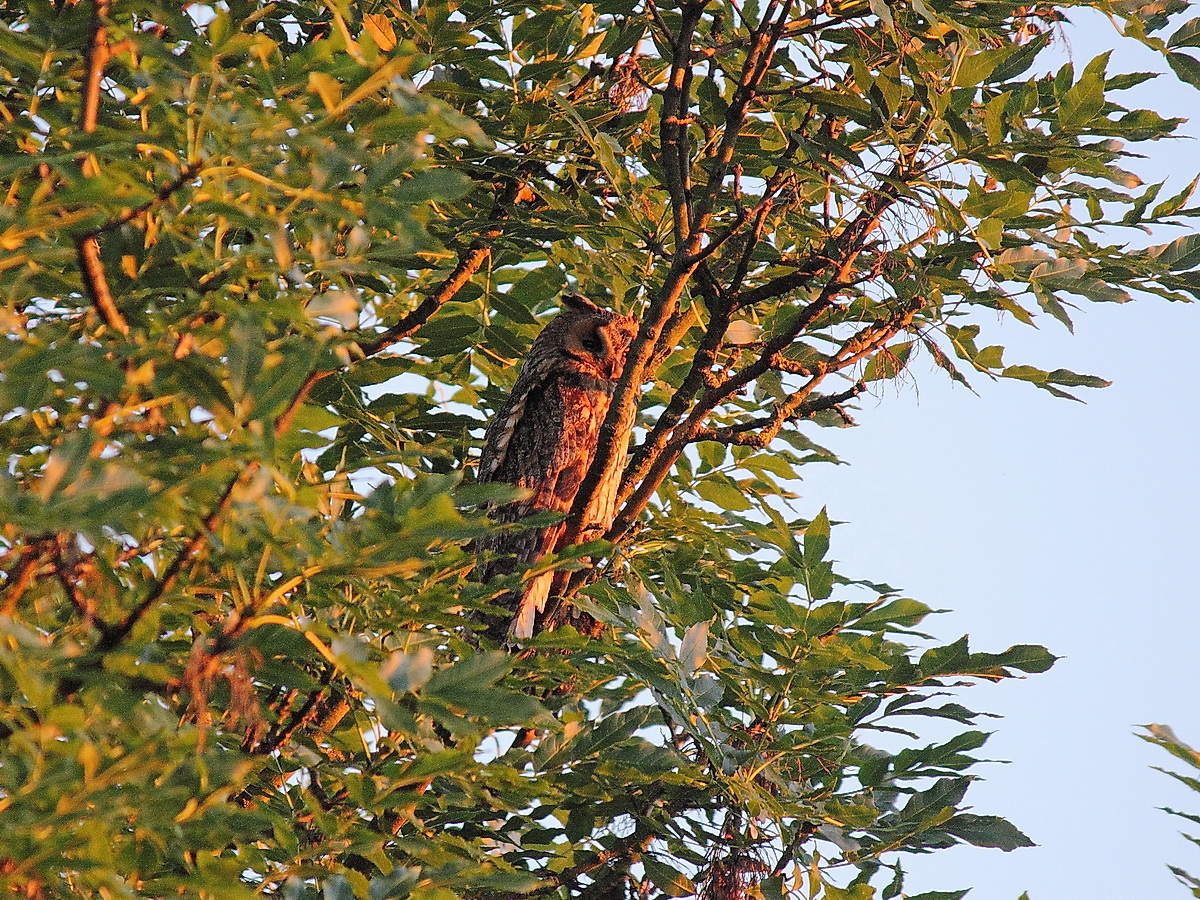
[0,0,1200,900]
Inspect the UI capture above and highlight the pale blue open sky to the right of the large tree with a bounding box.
[800,7,1200,900]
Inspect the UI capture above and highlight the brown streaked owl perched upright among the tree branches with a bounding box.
[478,294,637,644]
